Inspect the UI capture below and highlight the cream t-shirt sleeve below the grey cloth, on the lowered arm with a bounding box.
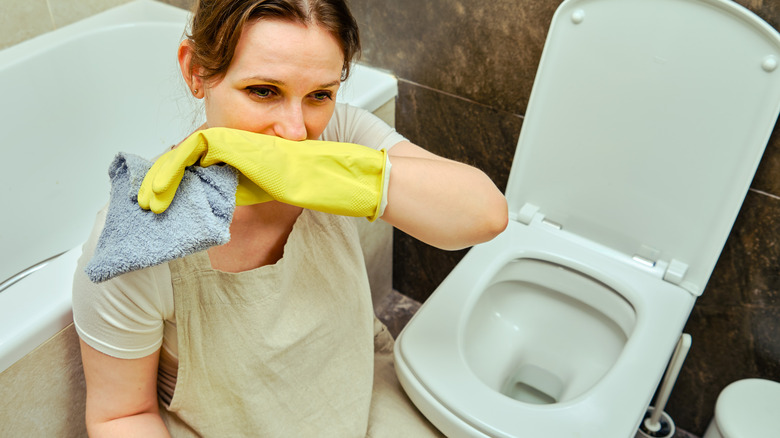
[73,208,173,359]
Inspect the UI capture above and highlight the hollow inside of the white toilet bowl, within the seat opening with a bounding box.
[462,259,636,404]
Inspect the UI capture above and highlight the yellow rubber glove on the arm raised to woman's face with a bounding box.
[138,128,390,221]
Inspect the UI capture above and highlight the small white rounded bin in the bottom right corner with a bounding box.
[704,379,780,438]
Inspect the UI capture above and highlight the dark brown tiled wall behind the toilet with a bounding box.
[350,0,780,435]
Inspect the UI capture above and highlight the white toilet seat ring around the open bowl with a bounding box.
[396,222,695,437]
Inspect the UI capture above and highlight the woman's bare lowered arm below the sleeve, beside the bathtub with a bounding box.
[80,341,170,438]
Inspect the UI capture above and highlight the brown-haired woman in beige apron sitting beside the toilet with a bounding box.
[74,0,507,437]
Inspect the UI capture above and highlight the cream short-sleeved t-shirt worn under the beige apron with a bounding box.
[73,104,406,362]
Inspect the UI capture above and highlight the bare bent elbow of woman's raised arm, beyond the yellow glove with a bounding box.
[382,141,508,250]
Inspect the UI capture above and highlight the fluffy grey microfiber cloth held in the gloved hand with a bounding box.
[85,153,238,283]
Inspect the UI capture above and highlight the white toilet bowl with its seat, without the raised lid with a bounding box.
[395,222,695,438]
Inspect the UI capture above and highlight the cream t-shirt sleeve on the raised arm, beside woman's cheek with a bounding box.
[321,103,406,150]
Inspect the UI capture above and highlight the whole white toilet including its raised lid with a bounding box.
[394,0,780,438]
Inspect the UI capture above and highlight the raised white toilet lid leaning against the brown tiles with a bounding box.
[507,0,780,295]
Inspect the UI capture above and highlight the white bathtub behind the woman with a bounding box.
[0,0,397,373]
